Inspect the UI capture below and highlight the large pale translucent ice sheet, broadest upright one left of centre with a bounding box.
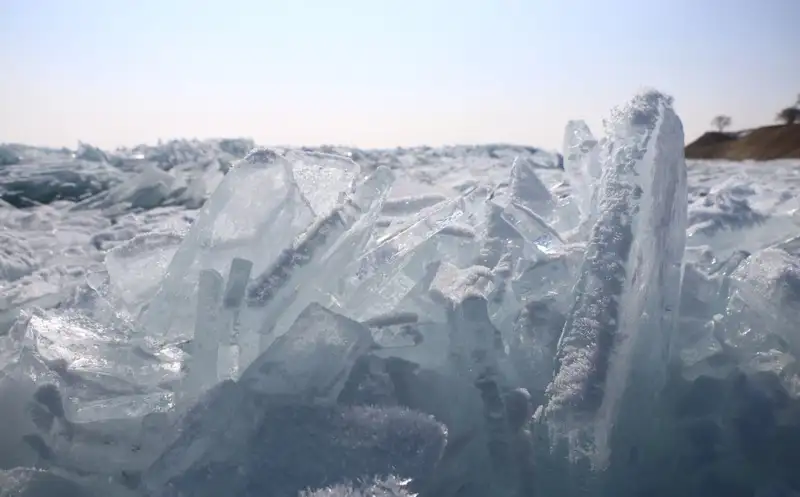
[140,149,326,341]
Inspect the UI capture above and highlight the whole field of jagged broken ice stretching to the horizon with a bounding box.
[0,91,800,497]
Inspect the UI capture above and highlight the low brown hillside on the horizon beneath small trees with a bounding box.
[686,124,800,160]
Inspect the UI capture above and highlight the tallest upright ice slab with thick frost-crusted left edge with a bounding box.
[545,92,687,466]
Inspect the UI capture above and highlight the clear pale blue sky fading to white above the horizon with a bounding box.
[0,0,800,148]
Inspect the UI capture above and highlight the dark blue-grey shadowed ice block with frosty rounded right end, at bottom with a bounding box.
[142,381,447,497]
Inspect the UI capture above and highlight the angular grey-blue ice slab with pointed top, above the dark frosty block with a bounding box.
[239,304,375,400]
